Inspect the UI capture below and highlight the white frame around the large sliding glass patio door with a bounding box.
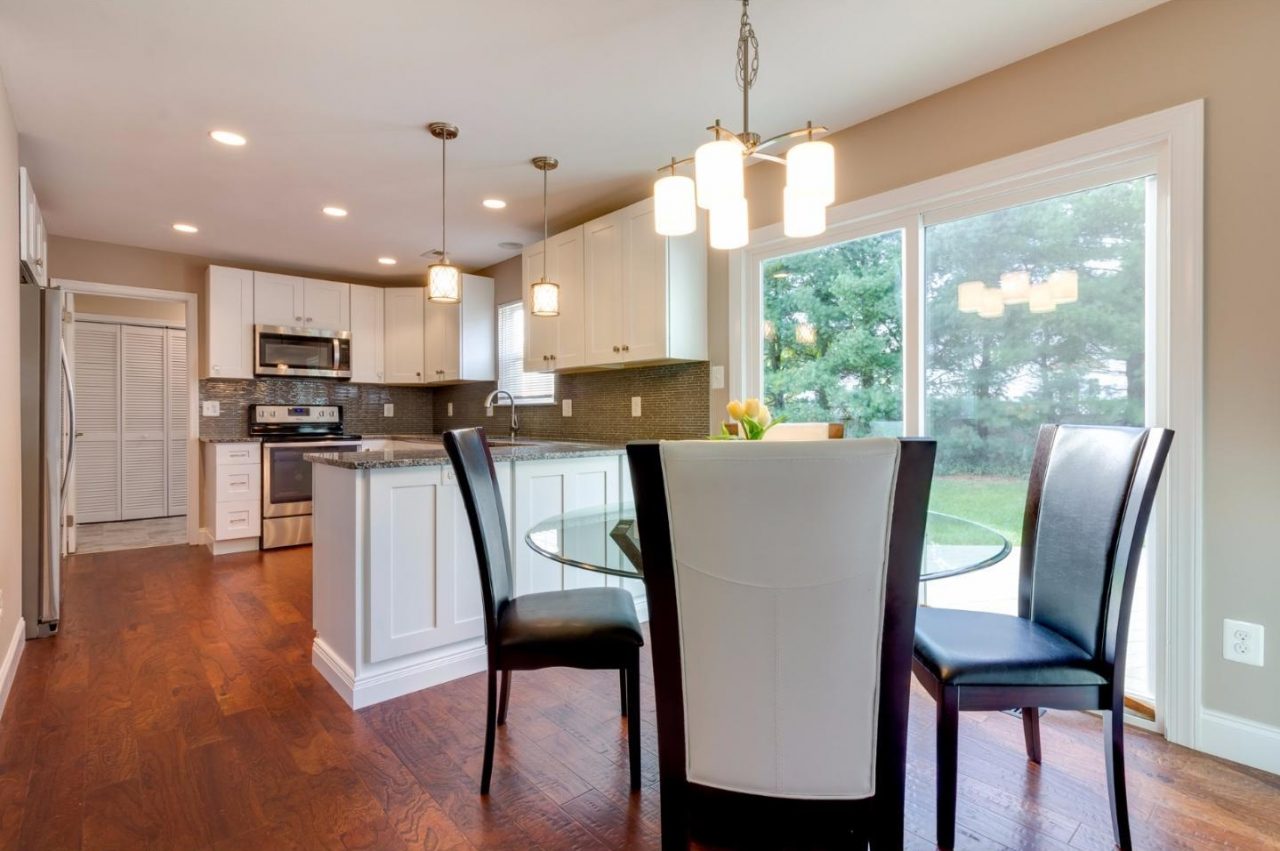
[727,100,1204,747]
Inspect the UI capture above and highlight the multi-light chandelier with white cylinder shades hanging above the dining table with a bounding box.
[653,0,836,250]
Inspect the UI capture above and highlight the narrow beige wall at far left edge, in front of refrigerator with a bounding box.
[0,72,26,706]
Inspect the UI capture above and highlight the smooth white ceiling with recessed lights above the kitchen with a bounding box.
[0,0,1161,276]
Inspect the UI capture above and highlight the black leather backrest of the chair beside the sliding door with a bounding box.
[1019,425,1174,673]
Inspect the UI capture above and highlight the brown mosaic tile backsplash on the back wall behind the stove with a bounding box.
[200,379,435,438]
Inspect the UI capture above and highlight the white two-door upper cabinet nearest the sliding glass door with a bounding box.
[584,198,707,366]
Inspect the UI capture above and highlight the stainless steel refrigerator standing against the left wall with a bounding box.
[19,284,76,639]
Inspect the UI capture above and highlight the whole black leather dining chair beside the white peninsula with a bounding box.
[444,429,644,795]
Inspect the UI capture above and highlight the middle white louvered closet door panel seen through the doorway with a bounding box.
[120,325,169,520]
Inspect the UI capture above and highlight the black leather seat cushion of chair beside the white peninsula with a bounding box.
[498,587,644,669]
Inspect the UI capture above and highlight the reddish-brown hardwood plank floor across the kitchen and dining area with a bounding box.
[0,546,1280,851]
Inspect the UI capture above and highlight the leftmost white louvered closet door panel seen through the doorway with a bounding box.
[72,322,120,525]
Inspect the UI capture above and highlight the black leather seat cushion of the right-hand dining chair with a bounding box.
[915,607,1106,686]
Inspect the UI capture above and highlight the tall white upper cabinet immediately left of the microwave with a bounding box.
[200,266,253,379]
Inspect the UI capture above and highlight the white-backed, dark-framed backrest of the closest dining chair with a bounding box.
[627,439,936,800]
